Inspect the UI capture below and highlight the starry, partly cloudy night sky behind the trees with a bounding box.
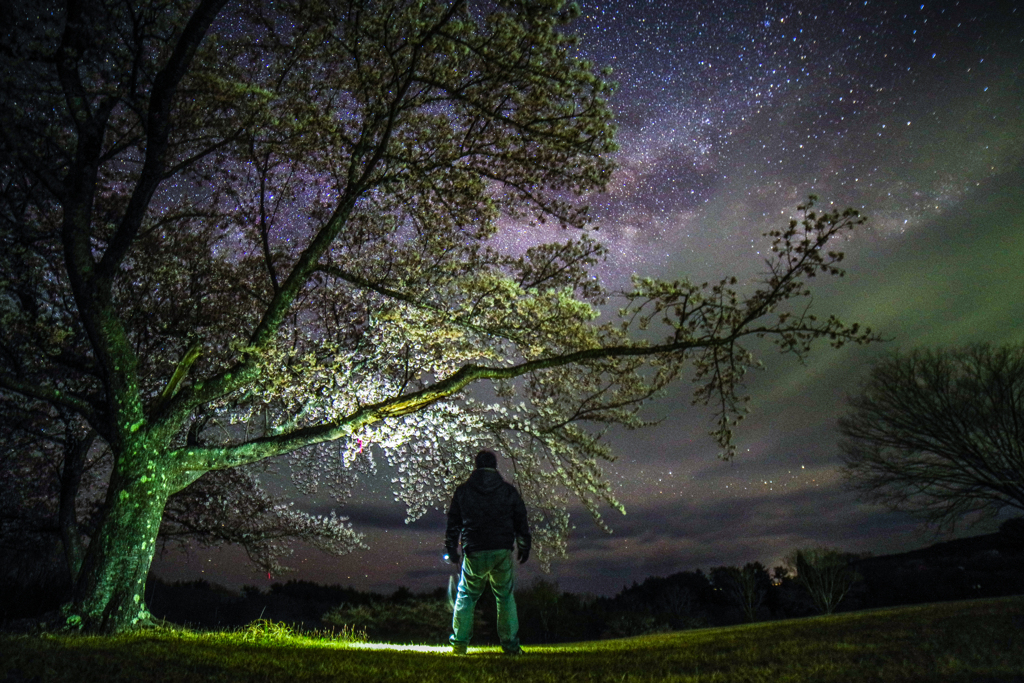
[154,0,1024,594]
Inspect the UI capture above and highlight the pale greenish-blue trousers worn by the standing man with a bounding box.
[449,550,519,652]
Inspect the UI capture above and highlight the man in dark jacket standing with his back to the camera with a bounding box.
[444,451,530,654]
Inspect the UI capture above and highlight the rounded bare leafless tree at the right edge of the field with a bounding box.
[839,344,1024,529]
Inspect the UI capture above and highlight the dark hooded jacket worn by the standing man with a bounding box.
[444,468,530,555]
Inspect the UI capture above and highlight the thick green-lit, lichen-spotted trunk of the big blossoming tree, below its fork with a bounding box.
[69,447,170,633]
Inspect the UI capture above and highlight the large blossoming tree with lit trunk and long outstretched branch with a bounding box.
[0,0,873,631]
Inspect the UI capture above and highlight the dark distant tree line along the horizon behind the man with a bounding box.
[8,518,1024,644]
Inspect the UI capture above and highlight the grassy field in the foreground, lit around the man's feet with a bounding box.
[0,597,1024,683]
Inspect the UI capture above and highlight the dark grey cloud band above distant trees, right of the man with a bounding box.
[536,482,925,593]
